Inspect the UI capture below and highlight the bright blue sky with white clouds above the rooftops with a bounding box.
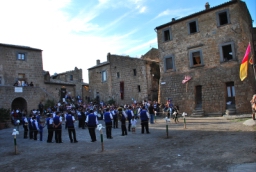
[0,0,256,83]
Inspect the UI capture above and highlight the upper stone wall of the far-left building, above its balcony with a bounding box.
[0,44,43,86]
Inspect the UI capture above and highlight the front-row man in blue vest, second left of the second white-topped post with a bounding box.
[66,111,78,143]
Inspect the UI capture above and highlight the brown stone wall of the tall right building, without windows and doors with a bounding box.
[157,2,255,114]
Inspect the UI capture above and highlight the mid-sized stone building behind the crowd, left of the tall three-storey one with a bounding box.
[88,48,160,104]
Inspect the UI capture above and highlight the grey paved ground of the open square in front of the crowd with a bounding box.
[0,117,256,172]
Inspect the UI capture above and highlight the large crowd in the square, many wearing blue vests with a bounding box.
[12,101,179,143]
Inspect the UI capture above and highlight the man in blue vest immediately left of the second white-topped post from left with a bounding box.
[85,110,98,142]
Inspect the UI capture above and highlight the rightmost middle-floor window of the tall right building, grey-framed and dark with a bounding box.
[220,42,235,62]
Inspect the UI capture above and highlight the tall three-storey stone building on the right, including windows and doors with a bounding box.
[155,0,255,116]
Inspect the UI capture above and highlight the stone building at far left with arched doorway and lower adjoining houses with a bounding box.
[0,44,89,112]
